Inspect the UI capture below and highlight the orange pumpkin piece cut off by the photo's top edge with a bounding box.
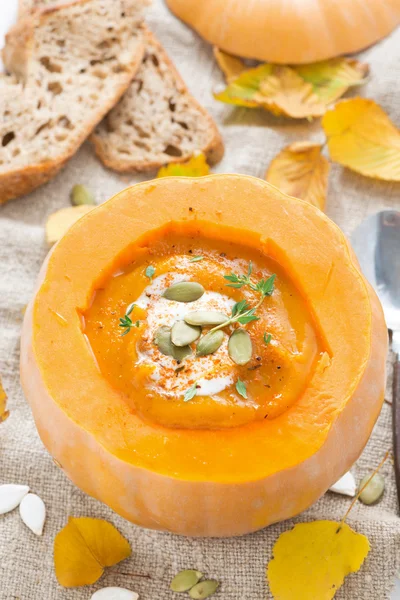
[166,0,400,64]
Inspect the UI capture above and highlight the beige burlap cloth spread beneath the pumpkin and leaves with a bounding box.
[0,0,400,600]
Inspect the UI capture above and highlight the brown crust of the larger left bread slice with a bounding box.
[0,0,145,204]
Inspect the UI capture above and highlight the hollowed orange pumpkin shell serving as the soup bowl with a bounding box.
[21,175,387,536]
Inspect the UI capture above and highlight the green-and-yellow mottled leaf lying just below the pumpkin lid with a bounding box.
[214,50,368,119]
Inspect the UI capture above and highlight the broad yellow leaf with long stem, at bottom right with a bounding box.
[267,521,370,600]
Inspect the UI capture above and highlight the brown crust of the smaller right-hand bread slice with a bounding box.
[90,25,224,173]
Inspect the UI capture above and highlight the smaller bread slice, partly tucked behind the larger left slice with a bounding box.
[90,29,224,172]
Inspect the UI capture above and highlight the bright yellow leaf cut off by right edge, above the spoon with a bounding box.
[322,98,400,181]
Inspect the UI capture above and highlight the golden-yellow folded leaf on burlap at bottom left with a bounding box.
[54,517,131,587]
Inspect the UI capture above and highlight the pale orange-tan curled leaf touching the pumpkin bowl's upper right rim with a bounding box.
[265,142,329,210]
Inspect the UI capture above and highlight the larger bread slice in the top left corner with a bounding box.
[0,0,148,203]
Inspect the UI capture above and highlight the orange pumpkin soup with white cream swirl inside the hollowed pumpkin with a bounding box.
[84,227,323,429]
